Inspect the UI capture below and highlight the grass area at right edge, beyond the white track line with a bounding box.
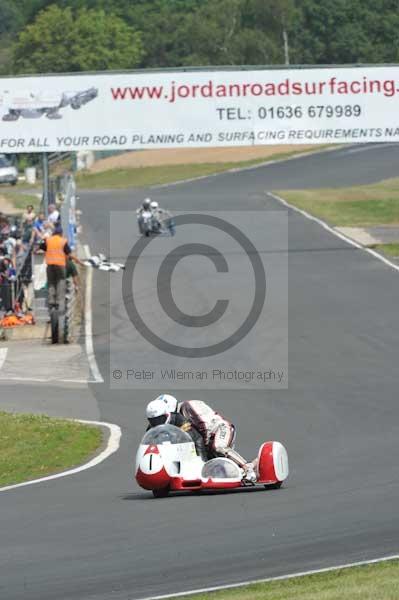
[277,178,399,227]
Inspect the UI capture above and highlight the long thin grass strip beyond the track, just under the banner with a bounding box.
[77,146,327,189]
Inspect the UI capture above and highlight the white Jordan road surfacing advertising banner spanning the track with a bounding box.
[0,66,399,153]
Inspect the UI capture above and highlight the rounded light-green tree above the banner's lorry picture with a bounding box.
[14,5,143,73]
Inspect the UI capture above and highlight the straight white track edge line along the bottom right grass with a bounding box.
[140,554,399,600]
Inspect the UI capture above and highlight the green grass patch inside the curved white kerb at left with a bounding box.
[0,412,102,487]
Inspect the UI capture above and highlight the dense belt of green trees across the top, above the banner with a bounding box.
[6,0,399,73]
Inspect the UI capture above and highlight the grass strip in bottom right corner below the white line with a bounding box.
[173,561,399,600]
